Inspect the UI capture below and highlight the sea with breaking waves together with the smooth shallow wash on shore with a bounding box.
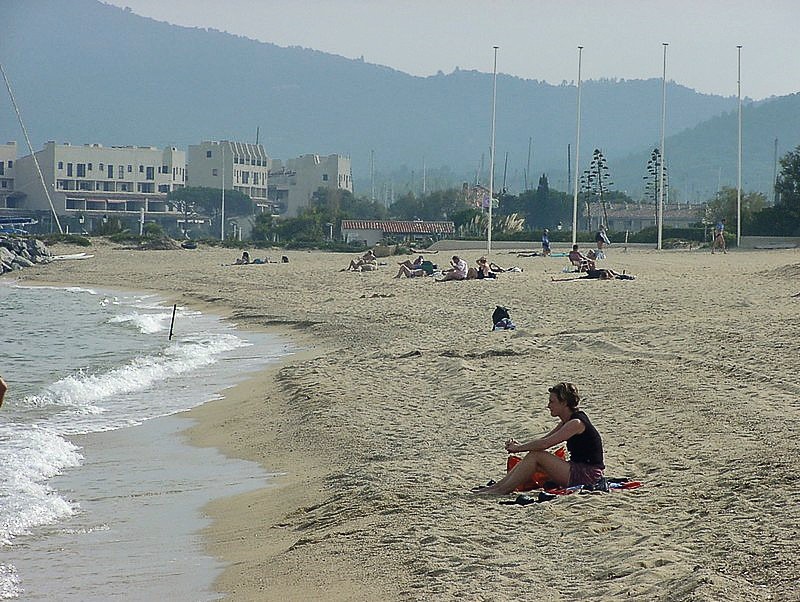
[0,282,291,600]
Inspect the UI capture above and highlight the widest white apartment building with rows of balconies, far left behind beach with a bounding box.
[15,141,186,229]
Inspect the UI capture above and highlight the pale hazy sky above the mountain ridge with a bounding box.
[109,0,800,99]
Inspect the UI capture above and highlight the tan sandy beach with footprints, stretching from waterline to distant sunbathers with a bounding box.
[12,241,800,601]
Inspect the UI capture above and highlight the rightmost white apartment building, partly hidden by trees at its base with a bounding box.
[269,155,353,217]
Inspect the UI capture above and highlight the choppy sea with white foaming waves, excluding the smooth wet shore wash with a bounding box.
[0,286,287,599]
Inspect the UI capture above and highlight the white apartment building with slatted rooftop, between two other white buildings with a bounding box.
[188,140,270,205]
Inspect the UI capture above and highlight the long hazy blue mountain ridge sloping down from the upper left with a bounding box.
[0,0,794,202]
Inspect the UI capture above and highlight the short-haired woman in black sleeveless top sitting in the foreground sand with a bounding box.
[475,382,605,495]
